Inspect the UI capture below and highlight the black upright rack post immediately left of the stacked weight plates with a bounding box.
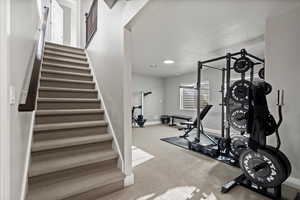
[225,53,231,139]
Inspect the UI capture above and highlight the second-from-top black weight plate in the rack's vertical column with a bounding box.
[229,80,251,104]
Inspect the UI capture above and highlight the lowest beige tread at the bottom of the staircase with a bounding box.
[27,168,124,200]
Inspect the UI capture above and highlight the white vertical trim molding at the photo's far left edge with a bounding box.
[0,0,11,200]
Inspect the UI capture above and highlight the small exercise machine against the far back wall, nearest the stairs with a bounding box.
[131,92,152,128]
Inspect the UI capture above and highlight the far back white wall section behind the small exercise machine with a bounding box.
[132,74,164,122]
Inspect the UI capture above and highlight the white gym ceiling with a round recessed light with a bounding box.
[130,0,300,77]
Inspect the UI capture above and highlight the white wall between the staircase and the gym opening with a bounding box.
[80,0,148,180]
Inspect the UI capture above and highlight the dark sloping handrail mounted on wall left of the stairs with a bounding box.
[18,7,49,112]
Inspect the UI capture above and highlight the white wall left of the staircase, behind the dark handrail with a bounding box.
[9,0,39,200]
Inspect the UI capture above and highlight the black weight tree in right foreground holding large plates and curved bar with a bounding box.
[221,82,292,200]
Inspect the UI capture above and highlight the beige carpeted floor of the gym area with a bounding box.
[99,126,296,200]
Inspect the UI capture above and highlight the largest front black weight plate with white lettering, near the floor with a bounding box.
[240,149,287,187]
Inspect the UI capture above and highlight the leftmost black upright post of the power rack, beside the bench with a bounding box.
[195,62,202,142]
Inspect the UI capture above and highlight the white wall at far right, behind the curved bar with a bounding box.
[265,7,300,188]
